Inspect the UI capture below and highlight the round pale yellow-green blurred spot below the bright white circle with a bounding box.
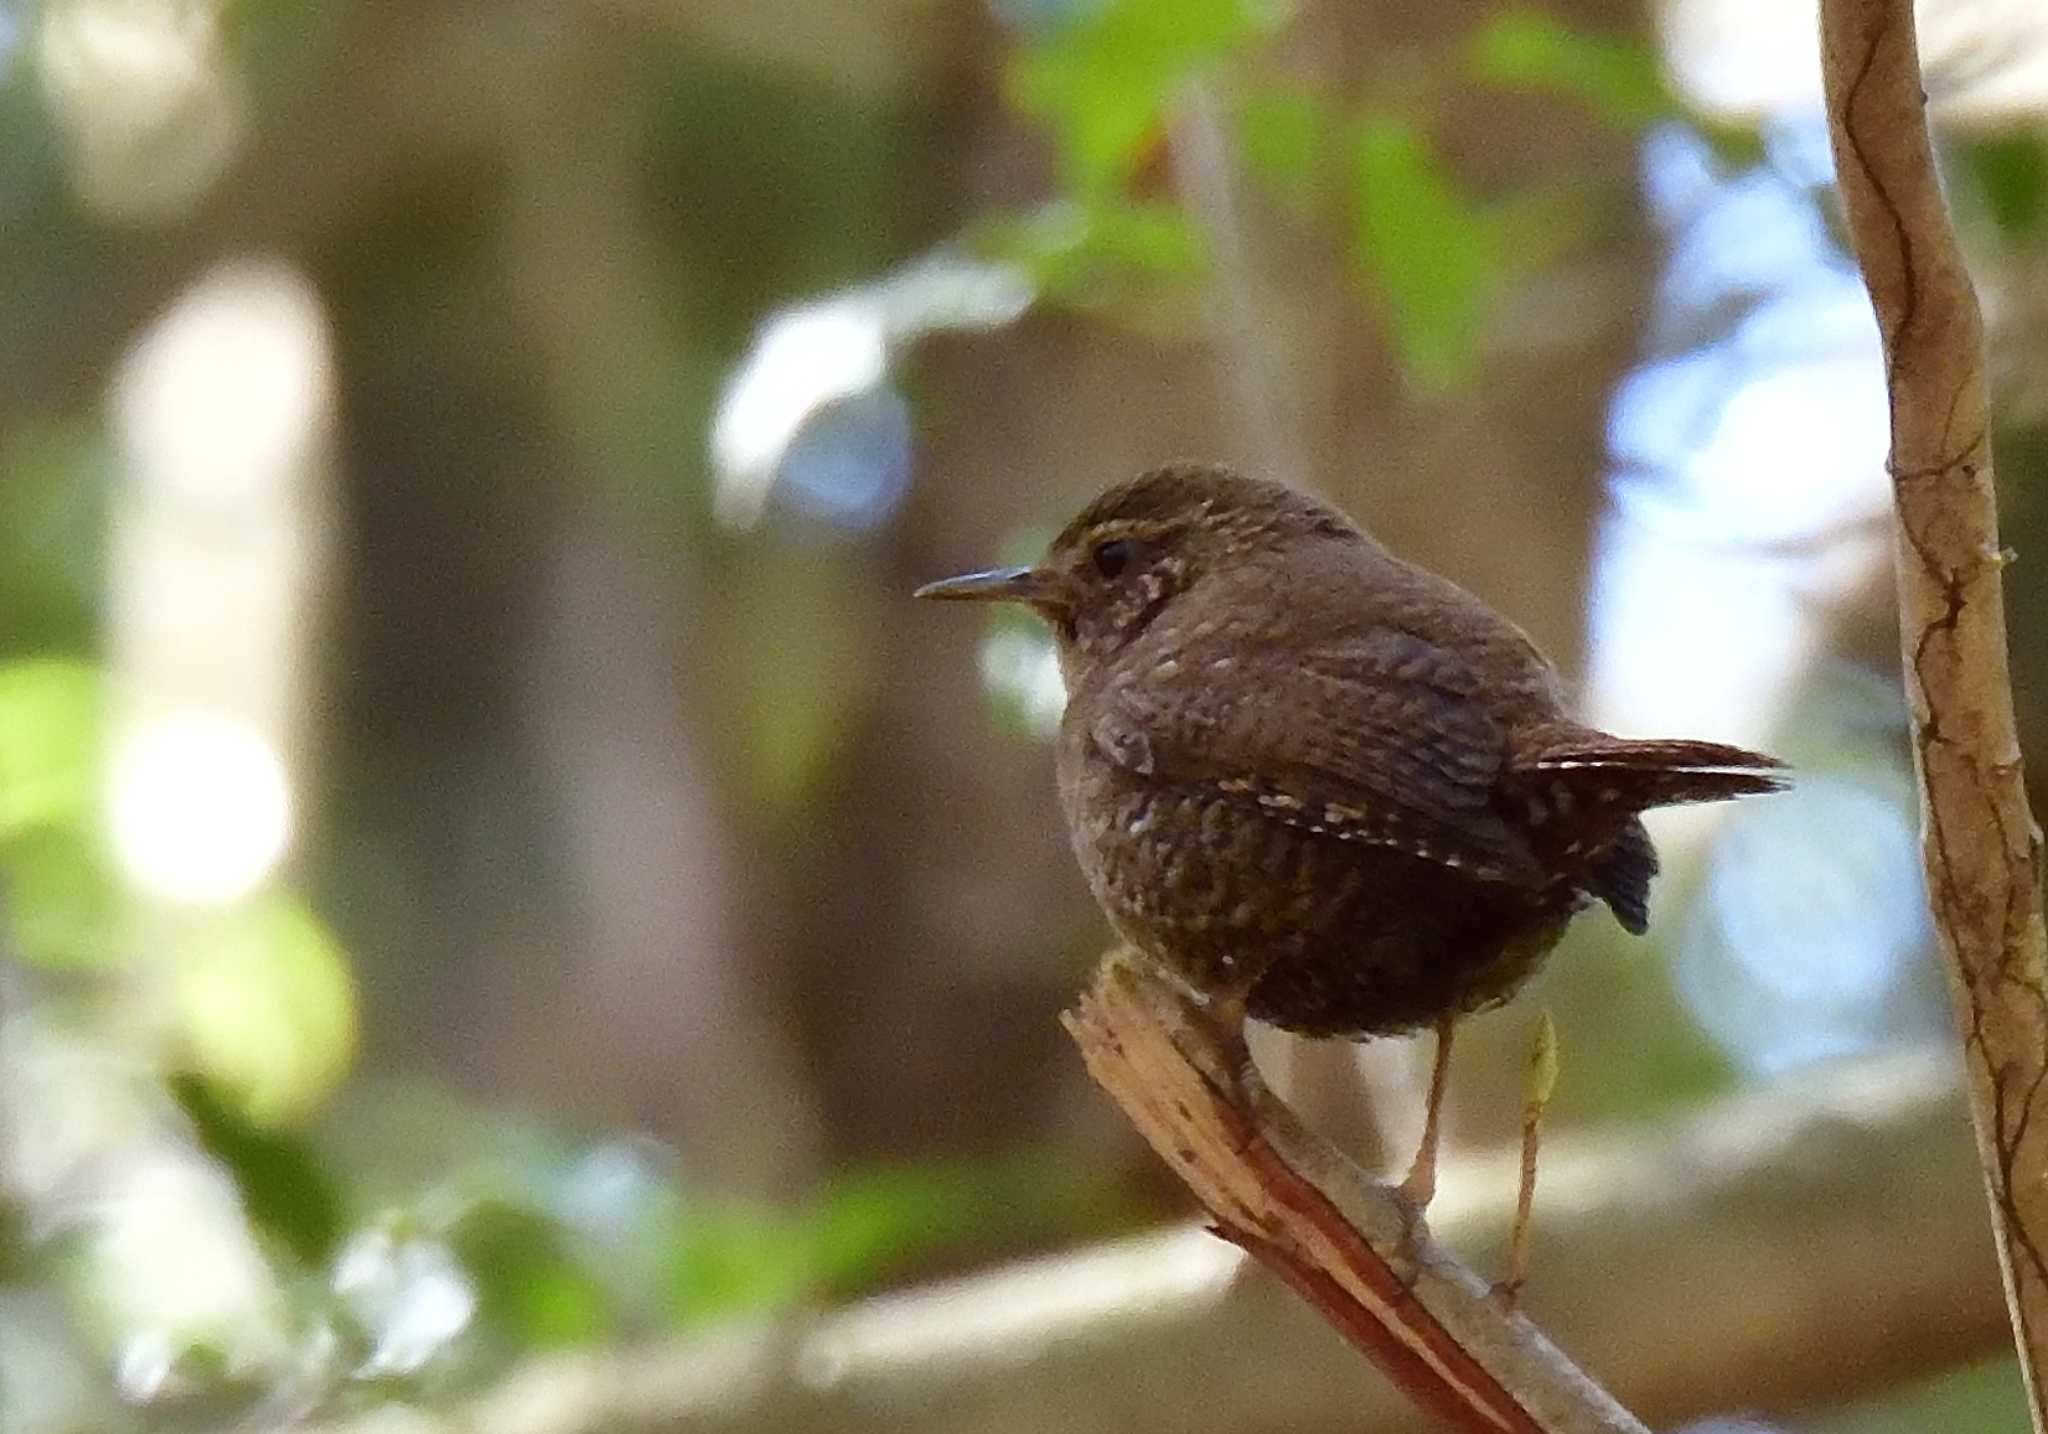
[170,895,356,1125]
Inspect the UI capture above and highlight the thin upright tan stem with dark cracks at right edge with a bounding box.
[1821,0,2048,1434]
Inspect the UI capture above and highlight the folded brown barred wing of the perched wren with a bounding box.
[1087,627,1540,883]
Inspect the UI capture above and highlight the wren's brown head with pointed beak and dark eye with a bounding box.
[918,463,1362,688]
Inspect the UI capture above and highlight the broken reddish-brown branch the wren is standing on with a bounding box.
[1067,959,1642,1434]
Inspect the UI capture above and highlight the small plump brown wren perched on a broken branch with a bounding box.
[918,465,1782,1207]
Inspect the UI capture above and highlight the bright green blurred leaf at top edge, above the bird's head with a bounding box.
[1010,0,1276,201]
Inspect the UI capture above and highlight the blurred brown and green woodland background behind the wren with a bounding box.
[0,0,2048,1434]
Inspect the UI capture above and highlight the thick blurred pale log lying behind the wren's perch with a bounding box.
[307,1051,2007,1434]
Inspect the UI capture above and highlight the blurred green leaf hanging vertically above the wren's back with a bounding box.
[1352,115,1497,385]
